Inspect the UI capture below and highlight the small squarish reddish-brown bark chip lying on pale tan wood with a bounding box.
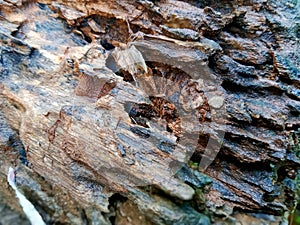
[75,73,116,98]
